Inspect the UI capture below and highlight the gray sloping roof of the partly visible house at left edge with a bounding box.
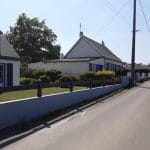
[0,34,20,59]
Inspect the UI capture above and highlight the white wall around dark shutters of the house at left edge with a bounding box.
[0,59,20,86]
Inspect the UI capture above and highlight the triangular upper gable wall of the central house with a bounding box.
[67,38,101,58]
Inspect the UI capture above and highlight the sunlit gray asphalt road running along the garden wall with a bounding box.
[3,82,150,150]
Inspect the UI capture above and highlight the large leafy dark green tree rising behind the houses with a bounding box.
[6,13,60,62]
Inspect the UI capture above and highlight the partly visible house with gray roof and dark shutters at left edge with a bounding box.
[0,31,20,87]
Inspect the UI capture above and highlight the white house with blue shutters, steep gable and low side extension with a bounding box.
[28,32,124,76]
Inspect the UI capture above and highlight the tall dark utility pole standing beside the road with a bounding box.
[131,0,136,86]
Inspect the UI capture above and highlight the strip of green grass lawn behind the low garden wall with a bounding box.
[0,86,86,102]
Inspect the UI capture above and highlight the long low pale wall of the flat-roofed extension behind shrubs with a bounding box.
[28,61,89,76]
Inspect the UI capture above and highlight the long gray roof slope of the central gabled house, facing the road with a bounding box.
[83,36,122,62]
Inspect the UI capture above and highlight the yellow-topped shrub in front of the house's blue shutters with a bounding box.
[95,70,115,80]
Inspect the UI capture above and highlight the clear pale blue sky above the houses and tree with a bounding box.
[0,0,150,64]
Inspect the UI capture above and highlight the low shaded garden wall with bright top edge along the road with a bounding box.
[0,77,129,129]
